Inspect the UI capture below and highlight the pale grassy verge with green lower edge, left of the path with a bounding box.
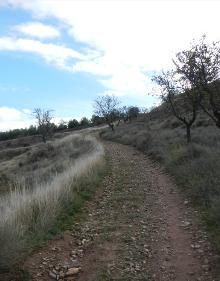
[0,133,106,271]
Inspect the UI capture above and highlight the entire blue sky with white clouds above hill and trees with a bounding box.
[0,0,220,131]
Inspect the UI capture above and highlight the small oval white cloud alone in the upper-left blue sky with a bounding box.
[14,22,60,39]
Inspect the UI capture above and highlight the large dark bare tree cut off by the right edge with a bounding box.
[174,35,220,128]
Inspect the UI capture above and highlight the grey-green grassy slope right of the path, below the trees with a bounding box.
[101,118,220,251]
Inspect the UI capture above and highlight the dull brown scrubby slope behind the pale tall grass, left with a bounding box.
[0,130,102,193]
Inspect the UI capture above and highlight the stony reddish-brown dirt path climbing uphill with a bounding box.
[23,143,217,281]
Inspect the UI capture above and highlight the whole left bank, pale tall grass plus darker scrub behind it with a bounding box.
[0,134,105,270]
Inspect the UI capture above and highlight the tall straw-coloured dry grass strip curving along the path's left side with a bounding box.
[0,135,104,268]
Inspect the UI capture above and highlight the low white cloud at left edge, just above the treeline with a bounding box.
[0,107,35,131]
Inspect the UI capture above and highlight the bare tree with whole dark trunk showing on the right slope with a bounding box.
[153,71,199,143]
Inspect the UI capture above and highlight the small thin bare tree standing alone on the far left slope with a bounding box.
[33,108,53,143]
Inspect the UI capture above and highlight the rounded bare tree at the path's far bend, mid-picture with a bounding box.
[94,95,120,131]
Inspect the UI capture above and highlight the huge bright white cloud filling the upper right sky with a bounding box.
[4,0,220,101]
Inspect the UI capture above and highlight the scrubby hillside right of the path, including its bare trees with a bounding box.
[101,36,220,250]
